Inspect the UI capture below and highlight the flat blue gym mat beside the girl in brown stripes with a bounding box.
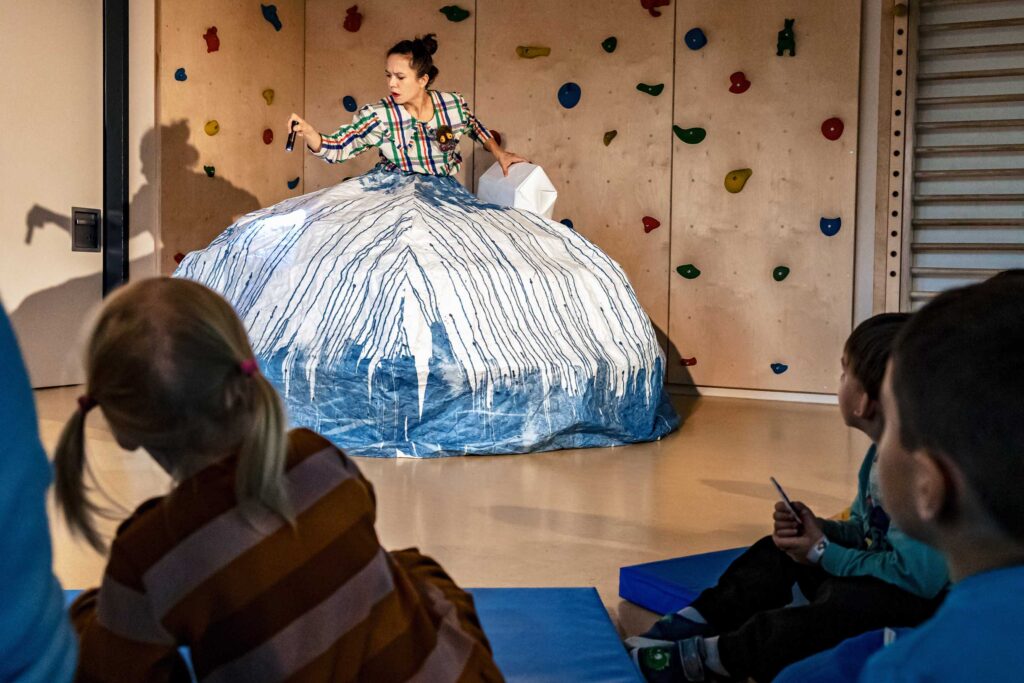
[65,588,643,683]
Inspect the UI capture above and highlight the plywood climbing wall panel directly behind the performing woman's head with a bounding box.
[304,0,475,191]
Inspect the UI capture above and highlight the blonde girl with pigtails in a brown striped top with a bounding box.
[55,279,502,683]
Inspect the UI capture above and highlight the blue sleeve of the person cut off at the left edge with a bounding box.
[0,306,77,683]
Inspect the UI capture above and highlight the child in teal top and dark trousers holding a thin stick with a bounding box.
[627,313,948,682]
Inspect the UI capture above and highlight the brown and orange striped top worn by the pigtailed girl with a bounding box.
[71,430,502,683]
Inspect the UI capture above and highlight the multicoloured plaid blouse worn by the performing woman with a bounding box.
[313,90,494,175]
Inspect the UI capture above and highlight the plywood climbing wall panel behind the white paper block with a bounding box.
[476,0,674,339]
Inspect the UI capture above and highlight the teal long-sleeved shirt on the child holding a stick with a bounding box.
[821,443,949,598]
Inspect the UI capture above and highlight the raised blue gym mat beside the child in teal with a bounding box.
[618,548,746,614]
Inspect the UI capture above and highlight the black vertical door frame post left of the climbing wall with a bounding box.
[102,0,130,297]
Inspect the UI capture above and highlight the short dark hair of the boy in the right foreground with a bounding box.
[893,275,1024,541]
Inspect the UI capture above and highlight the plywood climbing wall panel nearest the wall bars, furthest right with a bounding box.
[669,0,860,392]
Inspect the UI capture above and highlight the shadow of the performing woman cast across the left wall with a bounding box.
[10,121,260,385]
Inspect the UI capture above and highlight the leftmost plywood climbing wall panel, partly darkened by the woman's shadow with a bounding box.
[158,0,305,272]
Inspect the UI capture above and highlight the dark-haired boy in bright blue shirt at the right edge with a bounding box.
[861,271,1024,682]
